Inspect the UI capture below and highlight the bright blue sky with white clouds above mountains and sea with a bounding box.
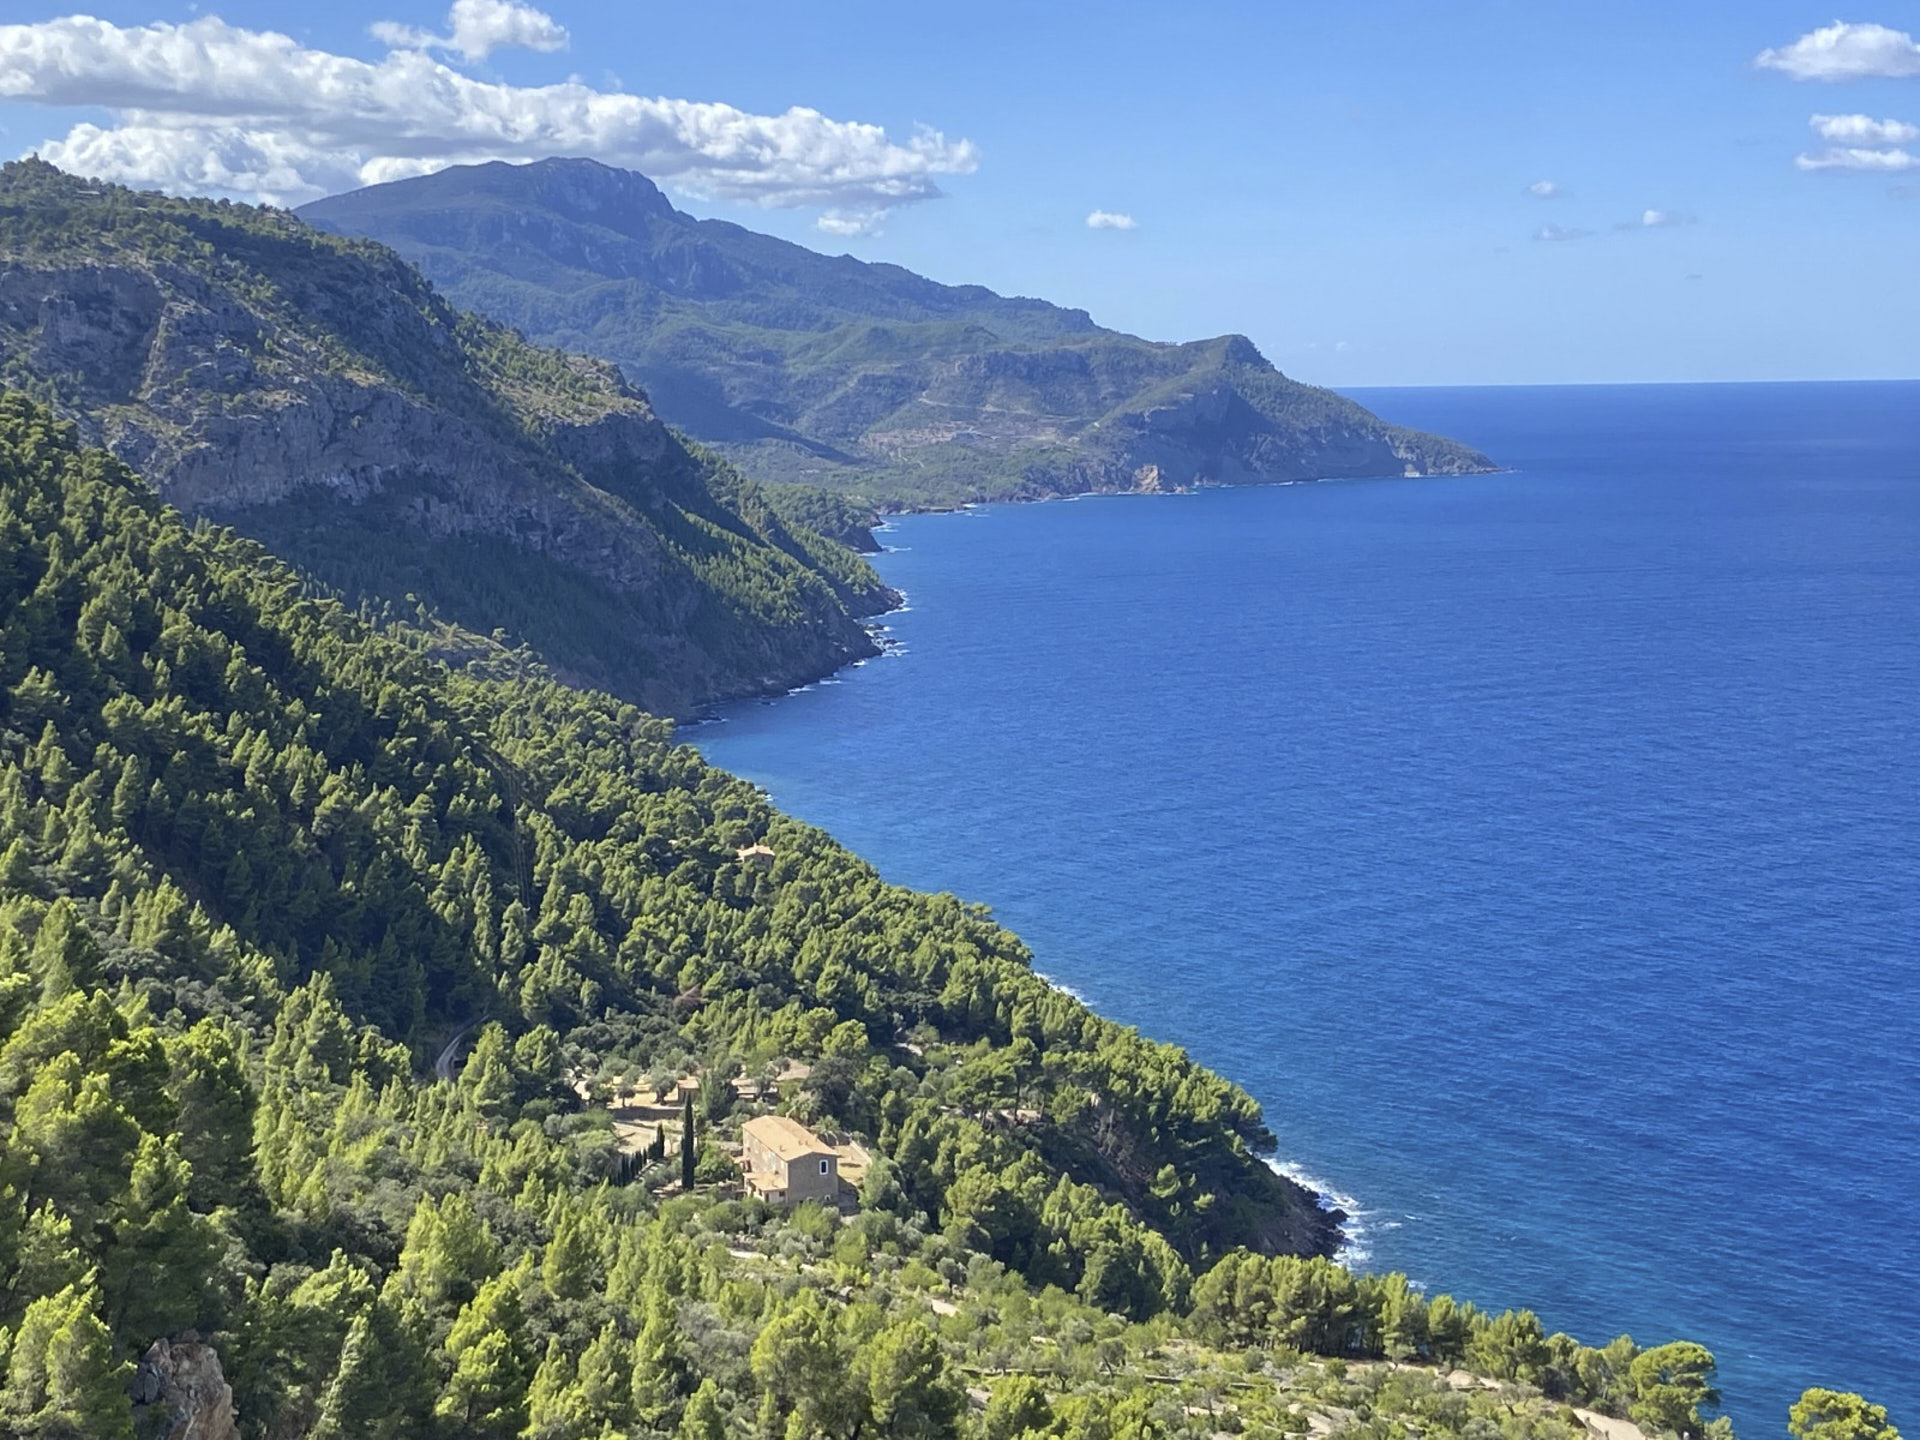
[0,0,1920,386]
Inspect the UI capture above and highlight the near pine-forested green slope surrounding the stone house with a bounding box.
[0,397,1872,1440]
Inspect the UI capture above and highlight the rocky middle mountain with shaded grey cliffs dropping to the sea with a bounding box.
[0,161,893,714]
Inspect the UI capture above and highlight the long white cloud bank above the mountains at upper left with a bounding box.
[0,9,979,218]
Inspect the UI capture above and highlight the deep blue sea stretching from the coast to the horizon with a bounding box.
[689,382,1920,1436]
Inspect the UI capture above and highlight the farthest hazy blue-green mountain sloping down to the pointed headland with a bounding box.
[300,159,1492,505]
